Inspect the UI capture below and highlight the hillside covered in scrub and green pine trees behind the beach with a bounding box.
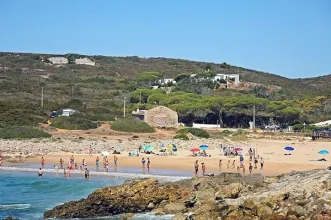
[0,53,331,133]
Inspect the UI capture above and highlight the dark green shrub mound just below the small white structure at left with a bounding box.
[51,115,97,130]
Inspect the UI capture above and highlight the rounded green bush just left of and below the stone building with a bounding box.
[111,118,154,133]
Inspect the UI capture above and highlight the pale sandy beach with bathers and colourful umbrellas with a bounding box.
[0,133,331,175]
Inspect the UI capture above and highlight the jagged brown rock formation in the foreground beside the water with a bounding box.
[44,170,331,220]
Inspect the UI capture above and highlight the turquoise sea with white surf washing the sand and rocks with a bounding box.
[0,164,192,220]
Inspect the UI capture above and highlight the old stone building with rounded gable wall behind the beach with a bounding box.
[132,106,178,128]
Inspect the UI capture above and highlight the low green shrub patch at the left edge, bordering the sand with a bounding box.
[0,127,52,139]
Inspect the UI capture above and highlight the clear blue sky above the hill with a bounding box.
[0,0,331,78]
